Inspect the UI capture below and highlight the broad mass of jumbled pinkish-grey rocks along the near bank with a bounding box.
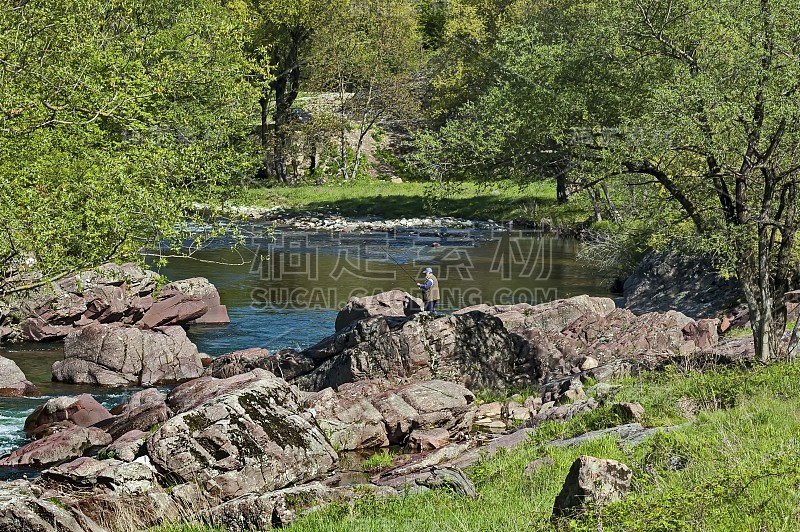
[0,291,747,531]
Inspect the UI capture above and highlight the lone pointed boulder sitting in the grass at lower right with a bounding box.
[553,455,632,518]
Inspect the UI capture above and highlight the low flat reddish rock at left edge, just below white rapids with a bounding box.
[0,425,111,467]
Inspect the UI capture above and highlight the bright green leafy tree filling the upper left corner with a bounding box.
[0,0,253,293]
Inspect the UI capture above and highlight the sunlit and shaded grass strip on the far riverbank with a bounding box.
[239,178,589,225]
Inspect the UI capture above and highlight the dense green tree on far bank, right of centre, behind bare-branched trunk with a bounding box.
[410,2,622,204]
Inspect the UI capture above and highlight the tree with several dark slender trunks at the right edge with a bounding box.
[607,0,800,360]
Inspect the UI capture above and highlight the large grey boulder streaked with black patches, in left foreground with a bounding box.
[147,370,337,500]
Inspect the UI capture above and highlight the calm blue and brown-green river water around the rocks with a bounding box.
[0,226,608,466]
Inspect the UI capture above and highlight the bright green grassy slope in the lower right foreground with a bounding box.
[153,363,800,532]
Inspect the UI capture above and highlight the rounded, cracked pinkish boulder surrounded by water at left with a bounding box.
[53,323,203,386]
